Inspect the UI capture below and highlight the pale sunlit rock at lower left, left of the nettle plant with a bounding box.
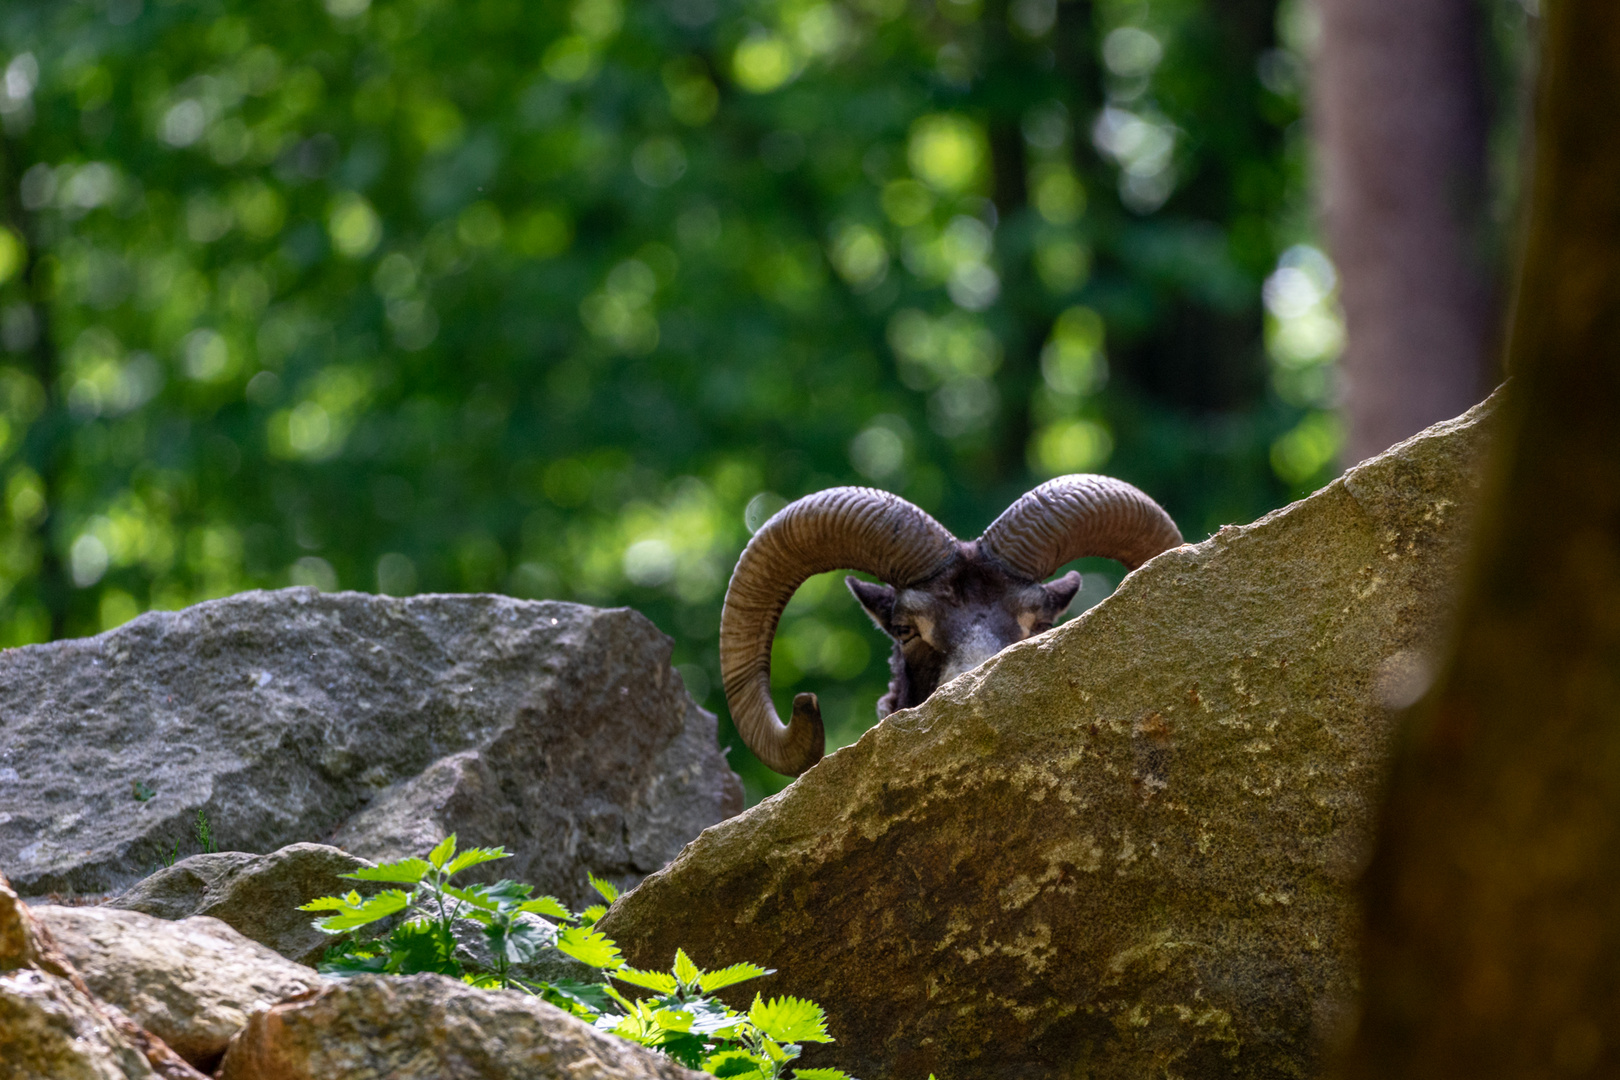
[32,905,321,1070]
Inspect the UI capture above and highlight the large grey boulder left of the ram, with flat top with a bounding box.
[0,588,742,902]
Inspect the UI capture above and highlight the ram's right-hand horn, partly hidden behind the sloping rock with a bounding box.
[978,473,1181,581]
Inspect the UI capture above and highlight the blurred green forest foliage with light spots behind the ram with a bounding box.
[0,0,1367,798]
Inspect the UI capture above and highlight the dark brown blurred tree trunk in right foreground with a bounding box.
[1349,0,1620,1080]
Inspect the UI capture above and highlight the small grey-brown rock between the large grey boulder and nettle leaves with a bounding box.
[109,844,372,967]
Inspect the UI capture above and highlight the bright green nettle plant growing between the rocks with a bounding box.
[300,834,861,1080]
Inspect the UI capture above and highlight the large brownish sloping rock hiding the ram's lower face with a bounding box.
[601,403,1494,1080]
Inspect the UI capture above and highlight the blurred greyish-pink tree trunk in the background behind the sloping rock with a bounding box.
[1312,0,1495,461]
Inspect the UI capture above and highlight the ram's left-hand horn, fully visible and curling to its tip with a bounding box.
[719,487,957,776]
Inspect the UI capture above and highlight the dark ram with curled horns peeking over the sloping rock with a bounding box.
[719,474,1181,776]
